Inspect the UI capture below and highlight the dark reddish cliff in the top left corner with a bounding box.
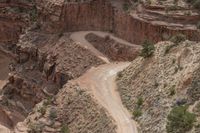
[0,0,33,43]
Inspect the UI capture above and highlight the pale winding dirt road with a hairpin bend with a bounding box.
[71,32,137,133]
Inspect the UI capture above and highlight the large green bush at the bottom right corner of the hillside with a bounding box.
[166,106,196,133]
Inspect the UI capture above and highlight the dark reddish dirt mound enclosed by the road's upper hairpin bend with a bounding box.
[85,33,139,61]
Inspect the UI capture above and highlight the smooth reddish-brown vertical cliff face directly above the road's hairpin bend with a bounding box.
[62,0,113,31]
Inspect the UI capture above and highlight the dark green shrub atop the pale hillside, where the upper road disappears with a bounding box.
[140,40,155,58]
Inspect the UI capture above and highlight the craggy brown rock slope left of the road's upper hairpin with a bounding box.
[0,31,104,129]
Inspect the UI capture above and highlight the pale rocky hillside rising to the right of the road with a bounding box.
[117,41,200,133]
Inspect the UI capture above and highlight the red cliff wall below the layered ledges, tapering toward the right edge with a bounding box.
[113,11,200,44]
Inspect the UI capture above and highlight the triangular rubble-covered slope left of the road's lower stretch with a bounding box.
[15,82,116,133]
